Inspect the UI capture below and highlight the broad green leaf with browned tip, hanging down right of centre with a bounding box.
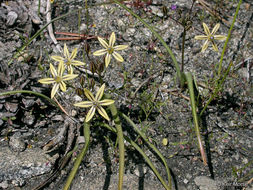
[185,73,207,165]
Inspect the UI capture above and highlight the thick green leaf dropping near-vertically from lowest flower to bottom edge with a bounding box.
[104,94,125,190]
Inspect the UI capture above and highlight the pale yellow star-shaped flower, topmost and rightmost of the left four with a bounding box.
[93,32,128,67]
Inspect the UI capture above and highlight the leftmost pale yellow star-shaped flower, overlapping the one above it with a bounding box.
[39,63,78,98]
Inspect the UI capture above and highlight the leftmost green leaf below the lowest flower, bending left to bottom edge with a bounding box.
[63,122,90,190]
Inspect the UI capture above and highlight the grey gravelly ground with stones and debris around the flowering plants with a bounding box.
[0,0,253,190]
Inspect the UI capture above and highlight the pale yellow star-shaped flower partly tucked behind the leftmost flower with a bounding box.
[51,44,85,74]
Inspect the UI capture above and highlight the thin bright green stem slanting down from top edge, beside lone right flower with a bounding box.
[218,0,242,78]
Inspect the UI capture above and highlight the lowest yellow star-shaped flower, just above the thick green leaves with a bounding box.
[74,84,114,122]
